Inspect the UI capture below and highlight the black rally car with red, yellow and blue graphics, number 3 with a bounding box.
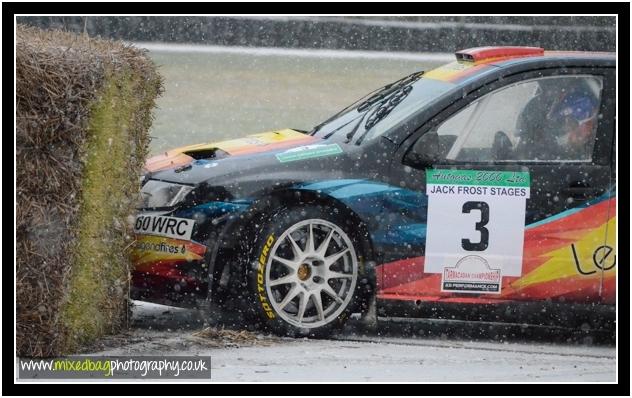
[132,47,616,335]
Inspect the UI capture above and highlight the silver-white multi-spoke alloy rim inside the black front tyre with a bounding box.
[265,219,358,329]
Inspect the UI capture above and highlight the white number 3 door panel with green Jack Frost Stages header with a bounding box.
[424,169,530,293]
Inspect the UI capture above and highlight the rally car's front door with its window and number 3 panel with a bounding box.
[382,68,614,302]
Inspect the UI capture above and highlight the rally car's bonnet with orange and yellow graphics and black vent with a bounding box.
[141,129,376,201]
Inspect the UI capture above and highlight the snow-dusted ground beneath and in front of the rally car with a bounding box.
[85,302,616,382]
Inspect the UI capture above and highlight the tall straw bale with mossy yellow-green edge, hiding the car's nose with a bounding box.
[16,25,162,357]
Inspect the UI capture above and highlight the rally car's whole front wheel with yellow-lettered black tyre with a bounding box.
[247,205,363,337]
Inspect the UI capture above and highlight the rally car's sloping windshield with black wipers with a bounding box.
[310,72,454,144]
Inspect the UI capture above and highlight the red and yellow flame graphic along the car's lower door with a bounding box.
[378,198,616,304]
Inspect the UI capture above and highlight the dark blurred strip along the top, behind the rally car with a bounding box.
[17,15,616,52]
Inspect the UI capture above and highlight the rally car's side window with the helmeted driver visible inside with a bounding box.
[436,75,603,162]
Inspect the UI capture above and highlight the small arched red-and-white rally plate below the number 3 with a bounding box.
[441,255,502,294]
